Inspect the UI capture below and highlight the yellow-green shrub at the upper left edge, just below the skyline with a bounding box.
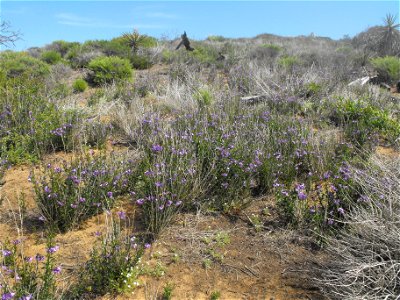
[0,51,50,80]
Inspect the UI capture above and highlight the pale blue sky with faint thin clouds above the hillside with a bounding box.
[0,0,399,50]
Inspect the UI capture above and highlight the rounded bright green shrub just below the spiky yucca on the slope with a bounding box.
[88,56,133,85]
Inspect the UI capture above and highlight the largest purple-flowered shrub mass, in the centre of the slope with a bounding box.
[133,107,340,234]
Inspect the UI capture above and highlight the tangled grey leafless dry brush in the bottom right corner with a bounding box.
[322,157,400,299]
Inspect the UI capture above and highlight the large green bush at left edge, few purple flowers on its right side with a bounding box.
[0,78,77,163]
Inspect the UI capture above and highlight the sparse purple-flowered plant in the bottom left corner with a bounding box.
[0,235,62,300]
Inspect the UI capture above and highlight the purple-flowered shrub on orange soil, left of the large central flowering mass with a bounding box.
[31,155,131,232]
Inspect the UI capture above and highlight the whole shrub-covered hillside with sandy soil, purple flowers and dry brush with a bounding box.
[0,18,400,300]
